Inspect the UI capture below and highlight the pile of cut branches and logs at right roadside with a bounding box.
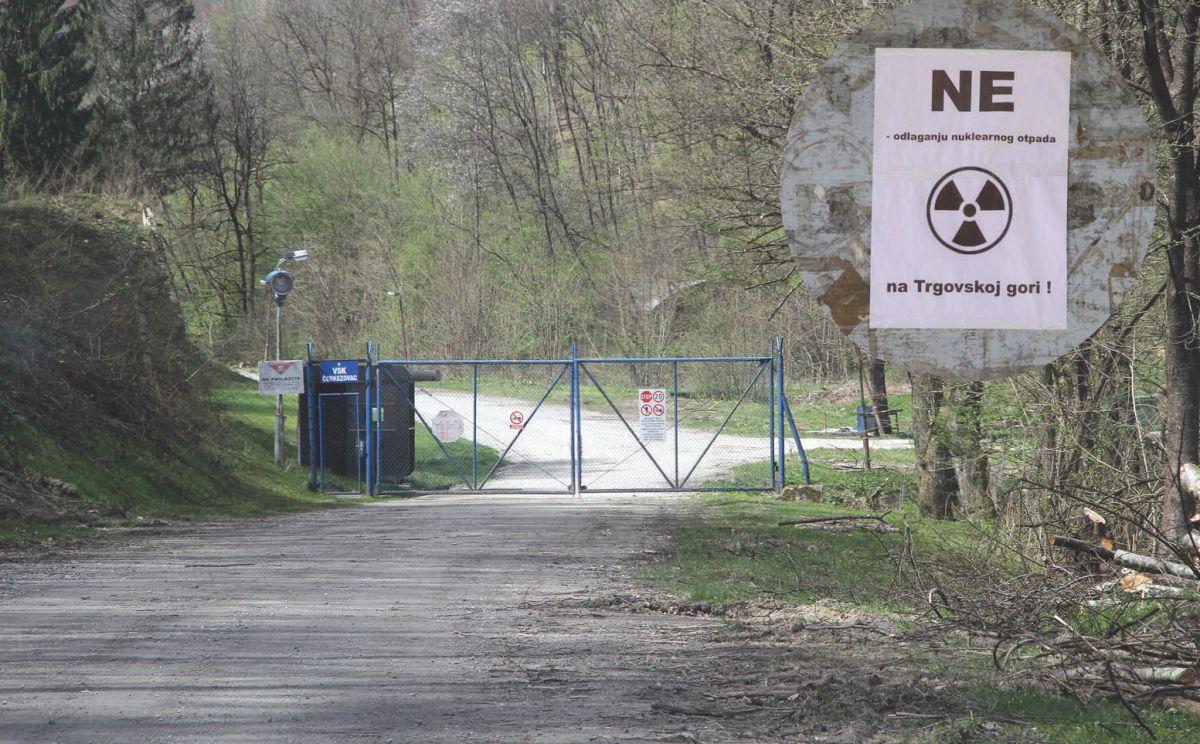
[901,508,1200,726]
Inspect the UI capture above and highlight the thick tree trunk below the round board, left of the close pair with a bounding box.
[912,374,959,520]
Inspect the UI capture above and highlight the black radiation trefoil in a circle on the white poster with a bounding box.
[925,167,1013,256]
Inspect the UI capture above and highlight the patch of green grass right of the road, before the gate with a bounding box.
[652,457,940,610]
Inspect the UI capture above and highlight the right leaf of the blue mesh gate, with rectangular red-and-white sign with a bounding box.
[577,358,775,491]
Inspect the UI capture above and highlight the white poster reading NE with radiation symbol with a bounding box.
[869,49,1070,329]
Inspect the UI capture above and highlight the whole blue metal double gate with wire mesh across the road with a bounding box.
[310,341,808,496]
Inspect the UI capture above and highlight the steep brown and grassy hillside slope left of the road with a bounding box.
[0,197,333,541]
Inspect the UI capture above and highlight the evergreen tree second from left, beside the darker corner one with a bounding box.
[91,0,212,193]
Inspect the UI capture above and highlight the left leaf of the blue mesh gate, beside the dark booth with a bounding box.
[376,361,574,493]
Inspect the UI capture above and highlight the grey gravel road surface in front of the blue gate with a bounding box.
[0,494,964,742]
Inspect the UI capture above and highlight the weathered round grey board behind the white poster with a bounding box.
[781,0,1156,379]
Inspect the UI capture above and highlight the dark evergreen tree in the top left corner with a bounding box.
[0,0,91,176]
